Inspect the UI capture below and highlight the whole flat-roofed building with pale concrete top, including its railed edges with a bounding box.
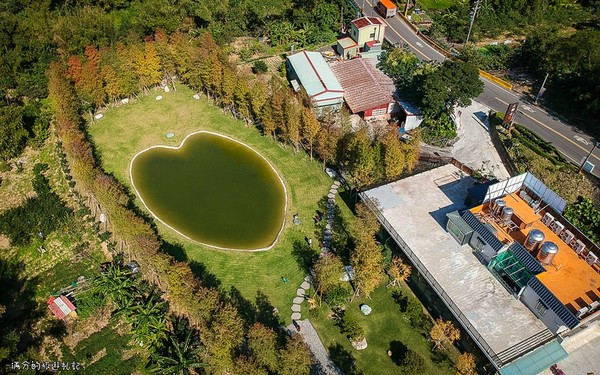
[360,165,573,375]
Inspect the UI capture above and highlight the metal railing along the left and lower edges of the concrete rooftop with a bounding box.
[359,192,553,369]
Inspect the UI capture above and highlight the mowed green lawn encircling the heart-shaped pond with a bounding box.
[88,85,332,323]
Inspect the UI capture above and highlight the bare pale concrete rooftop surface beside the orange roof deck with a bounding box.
[365,165,547,354]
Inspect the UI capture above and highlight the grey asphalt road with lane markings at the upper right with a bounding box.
[354,0,600,177]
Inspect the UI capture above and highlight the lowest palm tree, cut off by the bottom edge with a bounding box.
[151,318,208,375]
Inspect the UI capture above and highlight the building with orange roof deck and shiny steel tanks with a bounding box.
[449,173,600,333]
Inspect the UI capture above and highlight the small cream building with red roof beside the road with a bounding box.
[336,17,387,59]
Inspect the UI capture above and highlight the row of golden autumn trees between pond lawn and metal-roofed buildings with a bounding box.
[61,30,419,185]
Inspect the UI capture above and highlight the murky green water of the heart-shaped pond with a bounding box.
[131,133,285,250]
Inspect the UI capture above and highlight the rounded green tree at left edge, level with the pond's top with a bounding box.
[0,105,29,161]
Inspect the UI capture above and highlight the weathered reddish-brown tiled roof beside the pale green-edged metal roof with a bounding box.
[331,59,396,113]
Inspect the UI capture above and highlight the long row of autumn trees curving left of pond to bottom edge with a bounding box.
[47,60,310,374]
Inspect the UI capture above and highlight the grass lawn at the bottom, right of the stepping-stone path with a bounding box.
[310,285,458,375]
